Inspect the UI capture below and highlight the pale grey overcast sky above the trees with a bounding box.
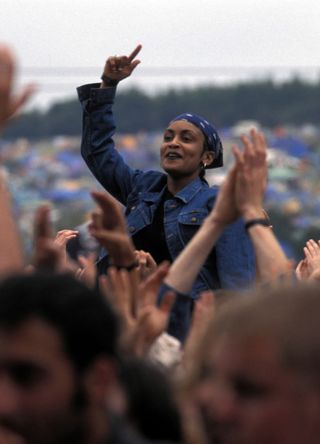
[0,0,320,109]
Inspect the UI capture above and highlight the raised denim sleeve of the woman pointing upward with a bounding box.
[77,84,143,205]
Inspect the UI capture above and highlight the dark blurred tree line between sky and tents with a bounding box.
[4,78,320,139]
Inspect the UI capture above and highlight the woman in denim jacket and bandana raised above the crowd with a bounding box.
[78,45,255,336]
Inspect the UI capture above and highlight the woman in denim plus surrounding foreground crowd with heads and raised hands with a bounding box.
[0,41,320,444]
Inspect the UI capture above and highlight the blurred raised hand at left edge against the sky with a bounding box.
[0,43,35,129]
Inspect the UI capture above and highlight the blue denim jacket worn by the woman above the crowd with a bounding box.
[78,84,255,336]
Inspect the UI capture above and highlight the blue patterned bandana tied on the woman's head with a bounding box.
[171,113,223,168]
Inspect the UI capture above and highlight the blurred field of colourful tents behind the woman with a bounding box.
[0,120,320,261]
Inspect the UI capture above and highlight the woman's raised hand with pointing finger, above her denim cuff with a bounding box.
[101,45,142,88]
